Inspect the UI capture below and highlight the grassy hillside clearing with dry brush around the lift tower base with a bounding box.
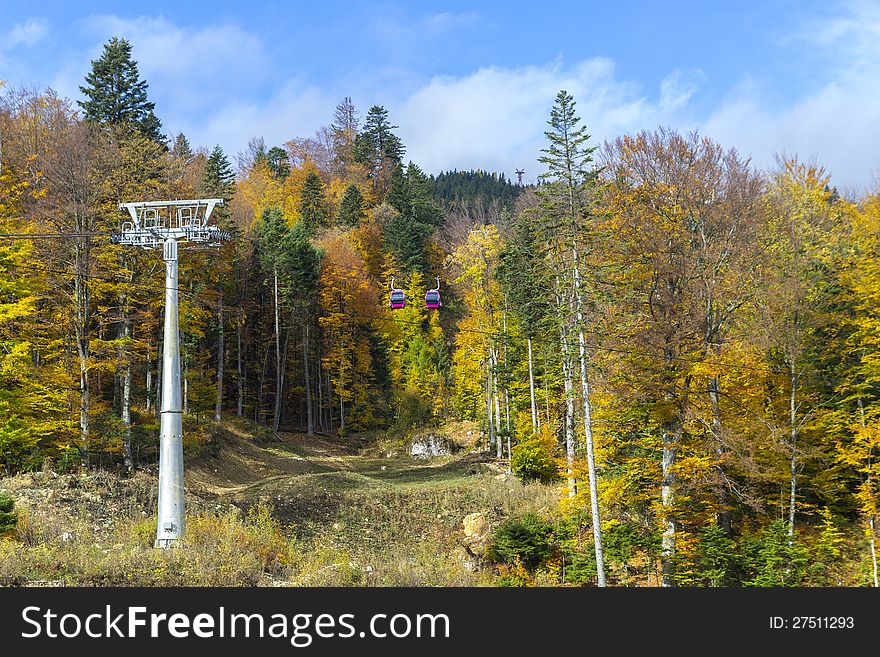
[0,422,557,586]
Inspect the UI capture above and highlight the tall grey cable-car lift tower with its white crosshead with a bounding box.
[113,198,230,548]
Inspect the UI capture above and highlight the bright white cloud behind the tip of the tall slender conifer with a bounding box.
[392,58,700,180]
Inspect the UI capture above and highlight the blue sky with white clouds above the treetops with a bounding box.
[0,0,880,193]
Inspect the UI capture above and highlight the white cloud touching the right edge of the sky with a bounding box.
[702,1,880,194]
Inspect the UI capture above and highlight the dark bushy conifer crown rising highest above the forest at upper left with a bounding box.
[78,37,165,142]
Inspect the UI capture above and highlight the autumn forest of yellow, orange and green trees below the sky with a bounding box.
[0,39,880,587]
